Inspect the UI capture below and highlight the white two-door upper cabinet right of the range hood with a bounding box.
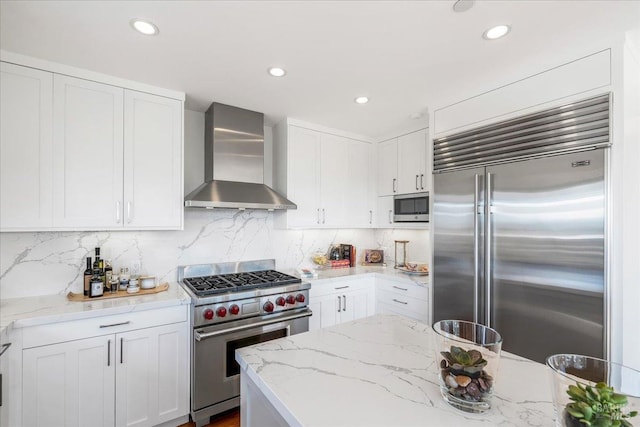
[274,122,373,228]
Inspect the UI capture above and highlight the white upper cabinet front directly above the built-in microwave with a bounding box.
[398,129,427,194]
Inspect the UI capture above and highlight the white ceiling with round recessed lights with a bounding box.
[0,0,640,137]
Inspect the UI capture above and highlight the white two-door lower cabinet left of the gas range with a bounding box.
[22,307,189,427]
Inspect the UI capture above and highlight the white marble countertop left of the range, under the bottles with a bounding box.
[0,282,191,333]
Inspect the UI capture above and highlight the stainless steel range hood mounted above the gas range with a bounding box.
[184,102,297,210]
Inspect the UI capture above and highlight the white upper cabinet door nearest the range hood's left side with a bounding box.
[124,90,183,230]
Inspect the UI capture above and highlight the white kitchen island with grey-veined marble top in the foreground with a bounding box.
[236,315,554,427]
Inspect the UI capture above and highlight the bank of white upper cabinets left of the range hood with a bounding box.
[0,58,184,231]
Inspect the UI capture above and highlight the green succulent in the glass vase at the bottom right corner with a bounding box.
[566,382,638,427]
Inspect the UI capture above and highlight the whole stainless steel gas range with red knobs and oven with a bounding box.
[178,259,312,427]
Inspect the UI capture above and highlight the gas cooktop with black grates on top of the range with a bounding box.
[183,270,302,296]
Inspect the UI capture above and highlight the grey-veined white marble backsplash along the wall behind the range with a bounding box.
[0,209,431,299]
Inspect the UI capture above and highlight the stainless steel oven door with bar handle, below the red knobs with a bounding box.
[192,307,312,411]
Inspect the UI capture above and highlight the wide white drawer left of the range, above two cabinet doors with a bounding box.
[22,305,188,348]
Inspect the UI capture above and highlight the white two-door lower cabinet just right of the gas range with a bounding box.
[309,279,375,331]
